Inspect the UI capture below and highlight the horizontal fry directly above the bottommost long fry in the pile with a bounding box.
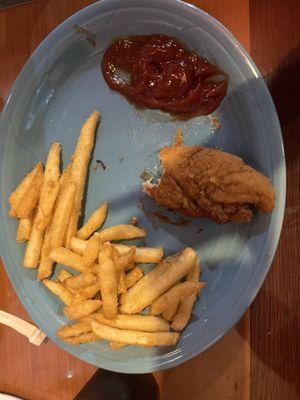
[83,310,170,332]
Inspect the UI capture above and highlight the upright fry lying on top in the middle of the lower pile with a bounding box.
[99,243,118,319]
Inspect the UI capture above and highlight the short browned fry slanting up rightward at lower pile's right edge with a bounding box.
[150,281,204,315]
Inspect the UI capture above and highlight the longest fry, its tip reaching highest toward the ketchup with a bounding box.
[66,111,100,246]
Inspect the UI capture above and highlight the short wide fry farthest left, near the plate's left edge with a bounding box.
[8,162,43,218]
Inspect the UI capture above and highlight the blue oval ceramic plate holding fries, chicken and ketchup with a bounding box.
[0,0,286,373]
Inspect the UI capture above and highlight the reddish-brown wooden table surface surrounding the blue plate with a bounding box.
[0,0,300,400]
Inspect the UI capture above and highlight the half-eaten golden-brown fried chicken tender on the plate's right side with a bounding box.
[144,141,275,224]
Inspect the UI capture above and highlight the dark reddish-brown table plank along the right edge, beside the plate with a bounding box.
[250,0,300,400]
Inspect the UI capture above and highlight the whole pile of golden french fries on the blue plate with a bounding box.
[9,111,204,349]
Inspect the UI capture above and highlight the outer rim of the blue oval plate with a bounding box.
[0,0,286,373]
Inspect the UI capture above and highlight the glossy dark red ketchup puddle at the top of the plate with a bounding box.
[102,35,227,118]
